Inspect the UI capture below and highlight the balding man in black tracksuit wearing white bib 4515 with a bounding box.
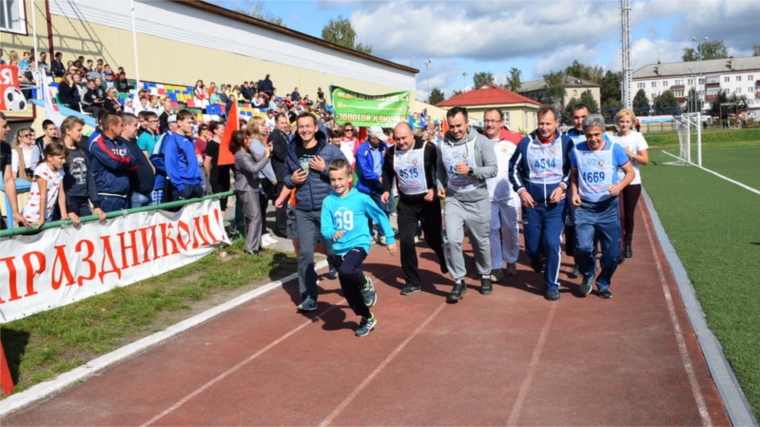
[381,123,448,295]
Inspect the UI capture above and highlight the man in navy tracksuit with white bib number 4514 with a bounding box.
[509,105,573,301]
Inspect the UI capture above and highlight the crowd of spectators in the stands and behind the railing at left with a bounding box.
[0,51,446,252]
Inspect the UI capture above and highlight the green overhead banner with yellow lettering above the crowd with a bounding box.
[330,86,411,127]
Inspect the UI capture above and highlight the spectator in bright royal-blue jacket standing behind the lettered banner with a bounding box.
[164,110,203,204]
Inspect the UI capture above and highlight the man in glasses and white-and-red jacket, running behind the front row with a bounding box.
[483,108,522,281]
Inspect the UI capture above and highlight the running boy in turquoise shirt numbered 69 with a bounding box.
[322,159,396,337]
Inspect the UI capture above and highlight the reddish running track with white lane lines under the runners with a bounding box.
[0,203,730,426]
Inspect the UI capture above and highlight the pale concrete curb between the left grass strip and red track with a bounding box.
[0,260,327,419]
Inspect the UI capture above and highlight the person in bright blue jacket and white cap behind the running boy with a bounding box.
[356,126,388,245]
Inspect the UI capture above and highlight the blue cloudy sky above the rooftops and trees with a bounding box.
[209,0,760,99]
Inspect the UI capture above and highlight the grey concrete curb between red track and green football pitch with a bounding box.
[641,191,758,426]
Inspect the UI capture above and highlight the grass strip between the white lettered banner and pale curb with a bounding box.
[0,239,297,391]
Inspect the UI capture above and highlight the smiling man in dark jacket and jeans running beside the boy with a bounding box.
[285,113,345,311]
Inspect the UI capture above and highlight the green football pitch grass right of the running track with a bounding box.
[639,145,760,417]
